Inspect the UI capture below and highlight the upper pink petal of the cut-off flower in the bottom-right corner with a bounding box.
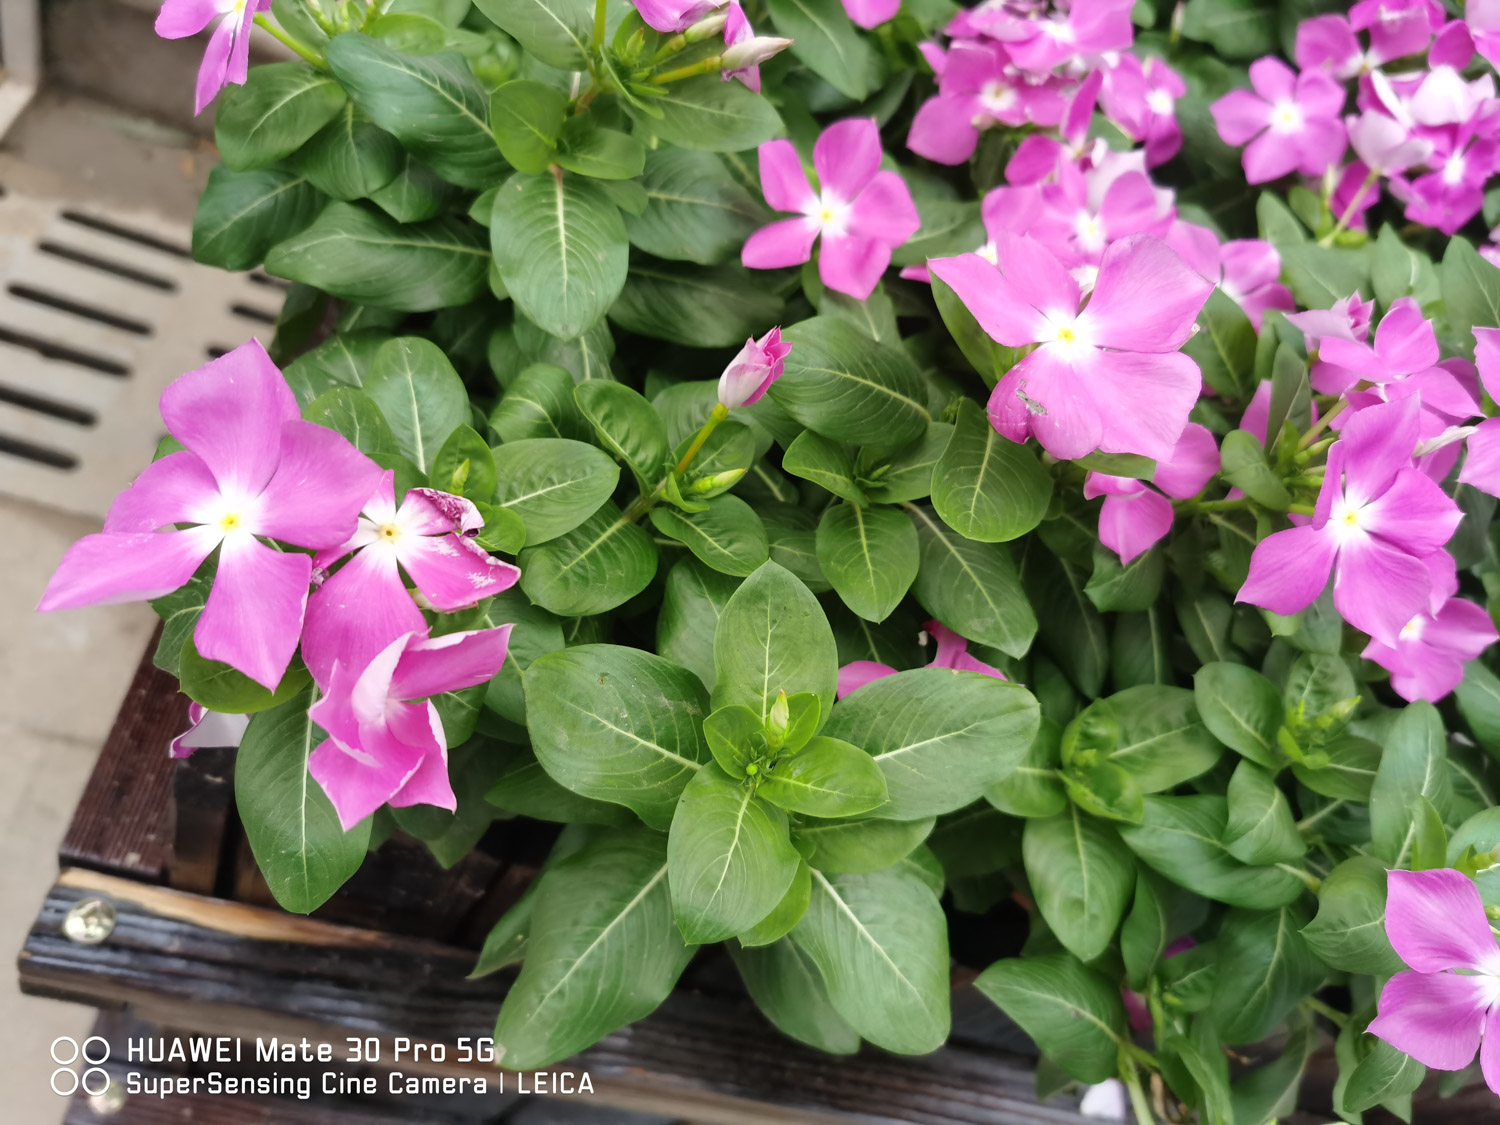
[1386,867,1500,974]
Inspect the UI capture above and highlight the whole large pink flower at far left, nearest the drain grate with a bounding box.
[39,341,380,687]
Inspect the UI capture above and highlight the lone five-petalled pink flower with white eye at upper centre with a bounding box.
[740,117,921,300]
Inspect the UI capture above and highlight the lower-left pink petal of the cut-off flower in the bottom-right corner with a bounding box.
[1368,972,1487,1071]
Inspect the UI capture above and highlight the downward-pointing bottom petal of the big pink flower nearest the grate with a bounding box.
[195,533,312,690]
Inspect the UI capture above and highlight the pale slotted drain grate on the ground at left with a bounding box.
[0,188,284,519]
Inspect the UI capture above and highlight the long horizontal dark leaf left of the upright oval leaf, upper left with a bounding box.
[266,203,489,312]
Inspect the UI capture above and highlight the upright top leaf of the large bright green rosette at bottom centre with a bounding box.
[714,563,858,732]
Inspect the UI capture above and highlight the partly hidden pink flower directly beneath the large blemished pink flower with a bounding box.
[1083,423,1220,566]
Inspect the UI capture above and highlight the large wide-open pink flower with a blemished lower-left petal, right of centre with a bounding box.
[930,231,1214,461]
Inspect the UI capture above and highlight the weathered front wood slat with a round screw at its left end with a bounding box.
[20,870,1082,1125]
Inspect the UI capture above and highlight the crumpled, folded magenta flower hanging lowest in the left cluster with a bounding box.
[308,626,512,831]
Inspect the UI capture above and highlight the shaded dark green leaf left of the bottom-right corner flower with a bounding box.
[1209,903,1328,1044]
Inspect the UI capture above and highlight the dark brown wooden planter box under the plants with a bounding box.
[11,644,1085,1125]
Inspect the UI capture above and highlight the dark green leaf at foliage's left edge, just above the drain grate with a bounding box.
[192,165,324,270]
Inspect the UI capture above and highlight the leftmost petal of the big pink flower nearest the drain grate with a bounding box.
[38,528,221,614]
